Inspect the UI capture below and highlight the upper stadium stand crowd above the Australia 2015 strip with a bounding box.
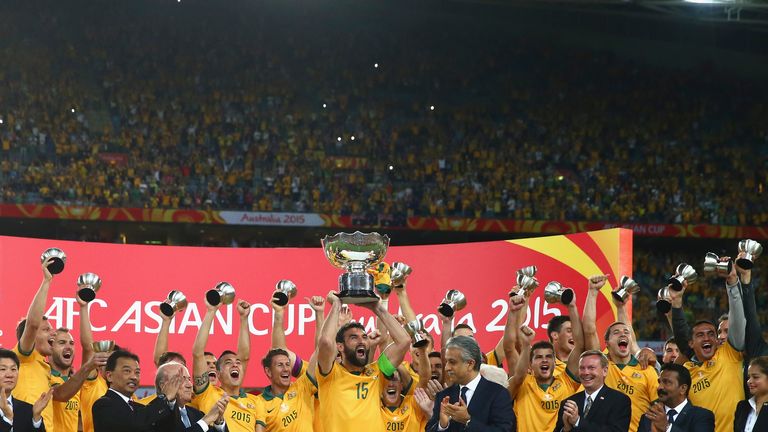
[0,3,768,226]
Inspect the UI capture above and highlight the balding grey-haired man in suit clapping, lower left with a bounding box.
[155,362,229,432]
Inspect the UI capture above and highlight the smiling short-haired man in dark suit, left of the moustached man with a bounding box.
[554,350,632,432]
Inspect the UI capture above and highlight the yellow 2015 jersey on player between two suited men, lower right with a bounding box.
[605,356,660,432]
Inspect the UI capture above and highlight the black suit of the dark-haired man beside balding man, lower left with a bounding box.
[93,389,172,432]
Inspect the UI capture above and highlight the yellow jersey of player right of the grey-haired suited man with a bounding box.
[514,372,580,432]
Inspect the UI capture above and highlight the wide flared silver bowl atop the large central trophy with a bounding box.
[322,231,389,269]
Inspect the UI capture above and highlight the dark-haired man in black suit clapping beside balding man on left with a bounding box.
[92,350,178,432]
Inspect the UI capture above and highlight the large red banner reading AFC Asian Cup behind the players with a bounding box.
[0,229,632,386]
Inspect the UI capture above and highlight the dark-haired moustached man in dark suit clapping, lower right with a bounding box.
[638,363,715,432]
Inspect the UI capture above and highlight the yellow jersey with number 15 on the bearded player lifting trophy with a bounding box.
[316,363,386,432]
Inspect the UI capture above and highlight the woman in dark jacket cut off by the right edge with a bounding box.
[733,357,768,432]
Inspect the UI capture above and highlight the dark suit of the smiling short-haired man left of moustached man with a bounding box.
[554,386,632,432]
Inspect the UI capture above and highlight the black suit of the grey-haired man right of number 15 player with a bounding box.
[426,377,515,432]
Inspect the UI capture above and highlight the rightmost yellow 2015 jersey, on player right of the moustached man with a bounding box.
[685,342,744,432]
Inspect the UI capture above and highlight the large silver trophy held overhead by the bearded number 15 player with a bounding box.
[322,231,389,304]
